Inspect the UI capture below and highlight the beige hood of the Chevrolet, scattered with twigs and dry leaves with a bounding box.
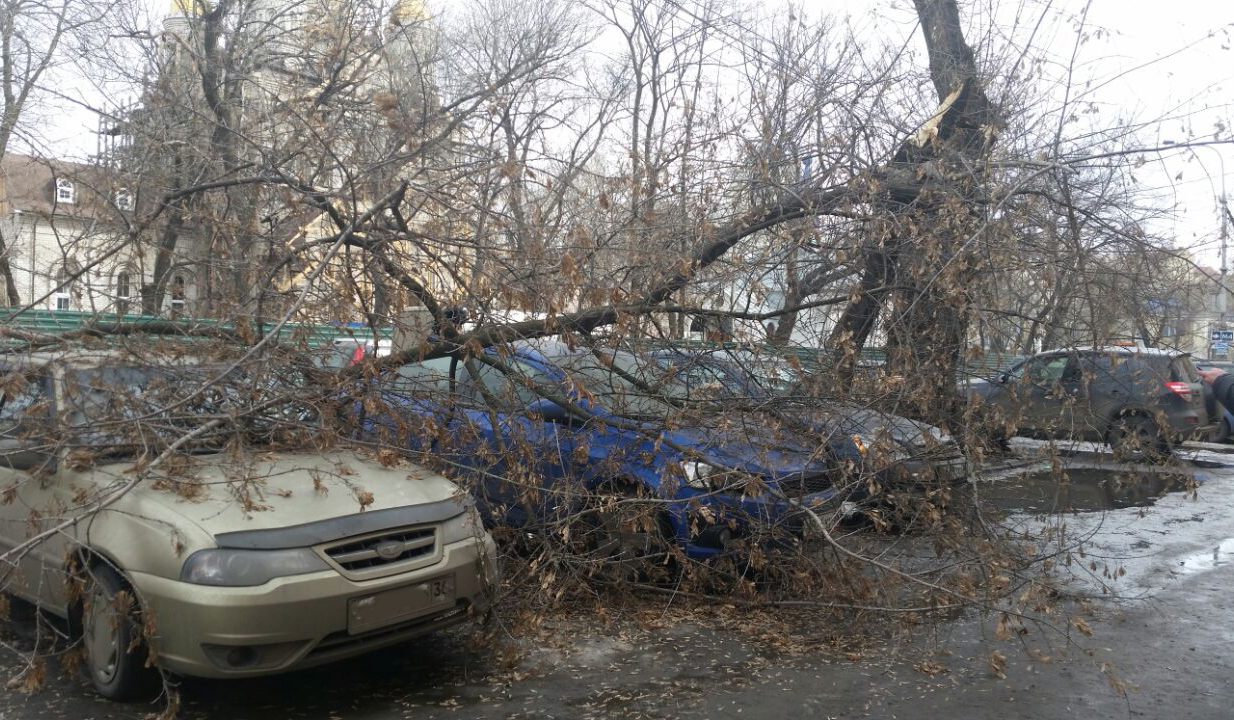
[95,451,462,536]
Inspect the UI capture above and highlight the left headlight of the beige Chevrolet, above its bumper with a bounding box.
[180,547,329,588]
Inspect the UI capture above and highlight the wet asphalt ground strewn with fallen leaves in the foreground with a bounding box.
[0,447,1234,720]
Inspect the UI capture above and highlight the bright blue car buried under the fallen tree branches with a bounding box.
[362,342,848,558]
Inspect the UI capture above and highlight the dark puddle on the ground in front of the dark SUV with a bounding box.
[980,468,1196,514]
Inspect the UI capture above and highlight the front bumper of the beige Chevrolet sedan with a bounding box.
[131,534,497,678]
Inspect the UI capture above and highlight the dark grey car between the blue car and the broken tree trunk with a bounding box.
[655,350,969,489]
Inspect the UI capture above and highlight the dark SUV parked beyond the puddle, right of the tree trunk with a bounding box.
[970,347,1217,461]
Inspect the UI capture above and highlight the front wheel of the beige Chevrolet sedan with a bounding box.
[80,563,158,700]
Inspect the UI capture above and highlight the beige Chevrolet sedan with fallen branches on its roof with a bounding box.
[0,353,496,699]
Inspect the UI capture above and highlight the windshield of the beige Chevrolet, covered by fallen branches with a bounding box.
[59,366,320,452]
